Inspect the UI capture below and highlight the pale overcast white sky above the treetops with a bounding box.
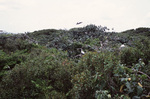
[0,0,150,33]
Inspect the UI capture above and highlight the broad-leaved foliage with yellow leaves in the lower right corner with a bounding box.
[114,60,150,99]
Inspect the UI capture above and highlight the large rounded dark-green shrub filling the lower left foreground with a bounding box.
[0,49,72,99]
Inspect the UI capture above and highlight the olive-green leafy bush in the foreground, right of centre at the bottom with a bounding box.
[71,52,118,99]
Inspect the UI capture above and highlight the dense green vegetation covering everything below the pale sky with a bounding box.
[0,24,150,99]
